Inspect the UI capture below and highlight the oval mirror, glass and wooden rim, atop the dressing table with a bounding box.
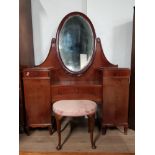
[57,12,95,73]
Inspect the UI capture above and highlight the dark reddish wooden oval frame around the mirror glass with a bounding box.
[56,12,96,75]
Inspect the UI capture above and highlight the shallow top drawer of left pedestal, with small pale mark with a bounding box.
[23,70,50,78]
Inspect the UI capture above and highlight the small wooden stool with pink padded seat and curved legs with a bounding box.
[53,100,97,150]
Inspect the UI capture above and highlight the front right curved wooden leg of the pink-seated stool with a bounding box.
[88,114,96,149]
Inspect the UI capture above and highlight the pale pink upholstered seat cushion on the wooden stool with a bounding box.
[53,100,97,116]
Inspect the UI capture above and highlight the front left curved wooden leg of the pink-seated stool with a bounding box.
[55,114,62,150]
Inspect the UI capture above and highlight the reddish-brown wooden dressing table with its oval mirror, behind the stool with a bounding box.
[22,12,130,134]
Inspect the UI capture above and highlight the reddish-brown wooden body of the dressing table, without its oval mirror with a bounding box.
[23,12,130,133]
